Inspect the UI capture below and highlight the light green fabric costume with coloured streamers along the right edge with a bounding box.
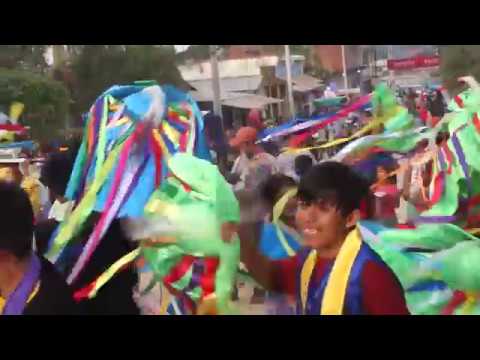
[352,82,480,315]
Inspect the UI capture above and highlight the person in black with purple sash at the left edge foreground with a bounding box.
[0,182,79,315]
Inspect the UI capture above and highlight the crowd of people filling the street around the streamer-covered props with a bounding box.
[0,75,476,315]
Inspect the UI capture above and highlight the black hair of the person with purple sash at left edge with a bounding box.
[0,182,33,259]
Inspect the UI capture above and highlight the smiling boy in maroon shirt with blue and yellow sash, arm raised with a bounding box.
[239,162,409,315]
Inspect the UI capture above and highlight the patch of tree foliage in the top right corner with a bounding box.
[440,45,480,93]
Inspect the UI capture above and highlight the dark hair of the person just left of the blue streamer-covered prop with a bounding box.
[40,150,75,196]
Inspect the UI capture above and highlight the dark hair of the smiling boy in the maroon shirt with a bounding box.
[298,161,370,216]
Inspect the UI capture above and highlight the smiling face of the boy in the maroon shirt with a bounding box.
[296,200,354,255]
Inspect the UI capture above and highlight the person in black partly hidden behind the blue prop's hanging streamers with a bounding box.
[35,153,140,315]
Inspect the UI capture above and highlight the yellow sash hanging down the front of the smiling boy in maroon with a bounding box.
[300,228,362,315]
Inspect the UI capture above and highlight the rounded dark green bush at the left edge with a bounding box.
[0,69,70,141]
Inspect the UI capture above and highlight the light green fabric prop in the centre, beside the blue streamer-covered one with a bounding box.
[143,153,240,313]
